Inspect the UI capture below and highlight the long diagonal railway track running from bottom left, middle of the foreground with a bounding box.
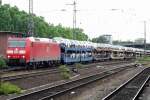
[9,64,134,100]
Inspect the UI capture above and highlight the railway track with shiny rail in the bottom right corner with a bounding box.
[102,67,150,100]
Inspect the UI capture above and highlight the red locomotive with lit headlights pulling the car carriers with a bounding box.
[7,37,61,66]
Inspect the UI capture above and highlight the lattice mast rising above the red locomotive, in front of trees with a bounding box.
[28,0,34,36]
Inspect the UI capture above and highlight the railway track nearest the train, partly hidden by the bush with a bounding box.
[2,61,131,81]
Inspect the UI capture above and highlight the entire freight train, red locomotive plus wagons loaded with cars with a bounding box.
[6,37,144,67]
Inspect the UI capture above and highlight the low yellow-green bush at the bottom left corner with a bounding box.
[0,82,21,95]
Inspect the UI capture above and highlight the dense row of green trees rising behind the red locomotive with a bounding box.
[0,4,88,40]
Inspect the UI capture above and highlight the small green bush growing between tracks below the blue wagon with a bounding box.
[59,65,71,79]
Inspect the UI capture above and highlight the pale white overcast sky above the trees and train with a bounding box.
[3,0,150,42]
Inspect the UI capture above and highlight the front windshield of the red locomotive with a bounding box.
[8,40,25,47]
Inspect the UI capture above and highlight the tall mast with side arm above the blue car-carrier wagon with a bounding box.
[66,0,77,39]
